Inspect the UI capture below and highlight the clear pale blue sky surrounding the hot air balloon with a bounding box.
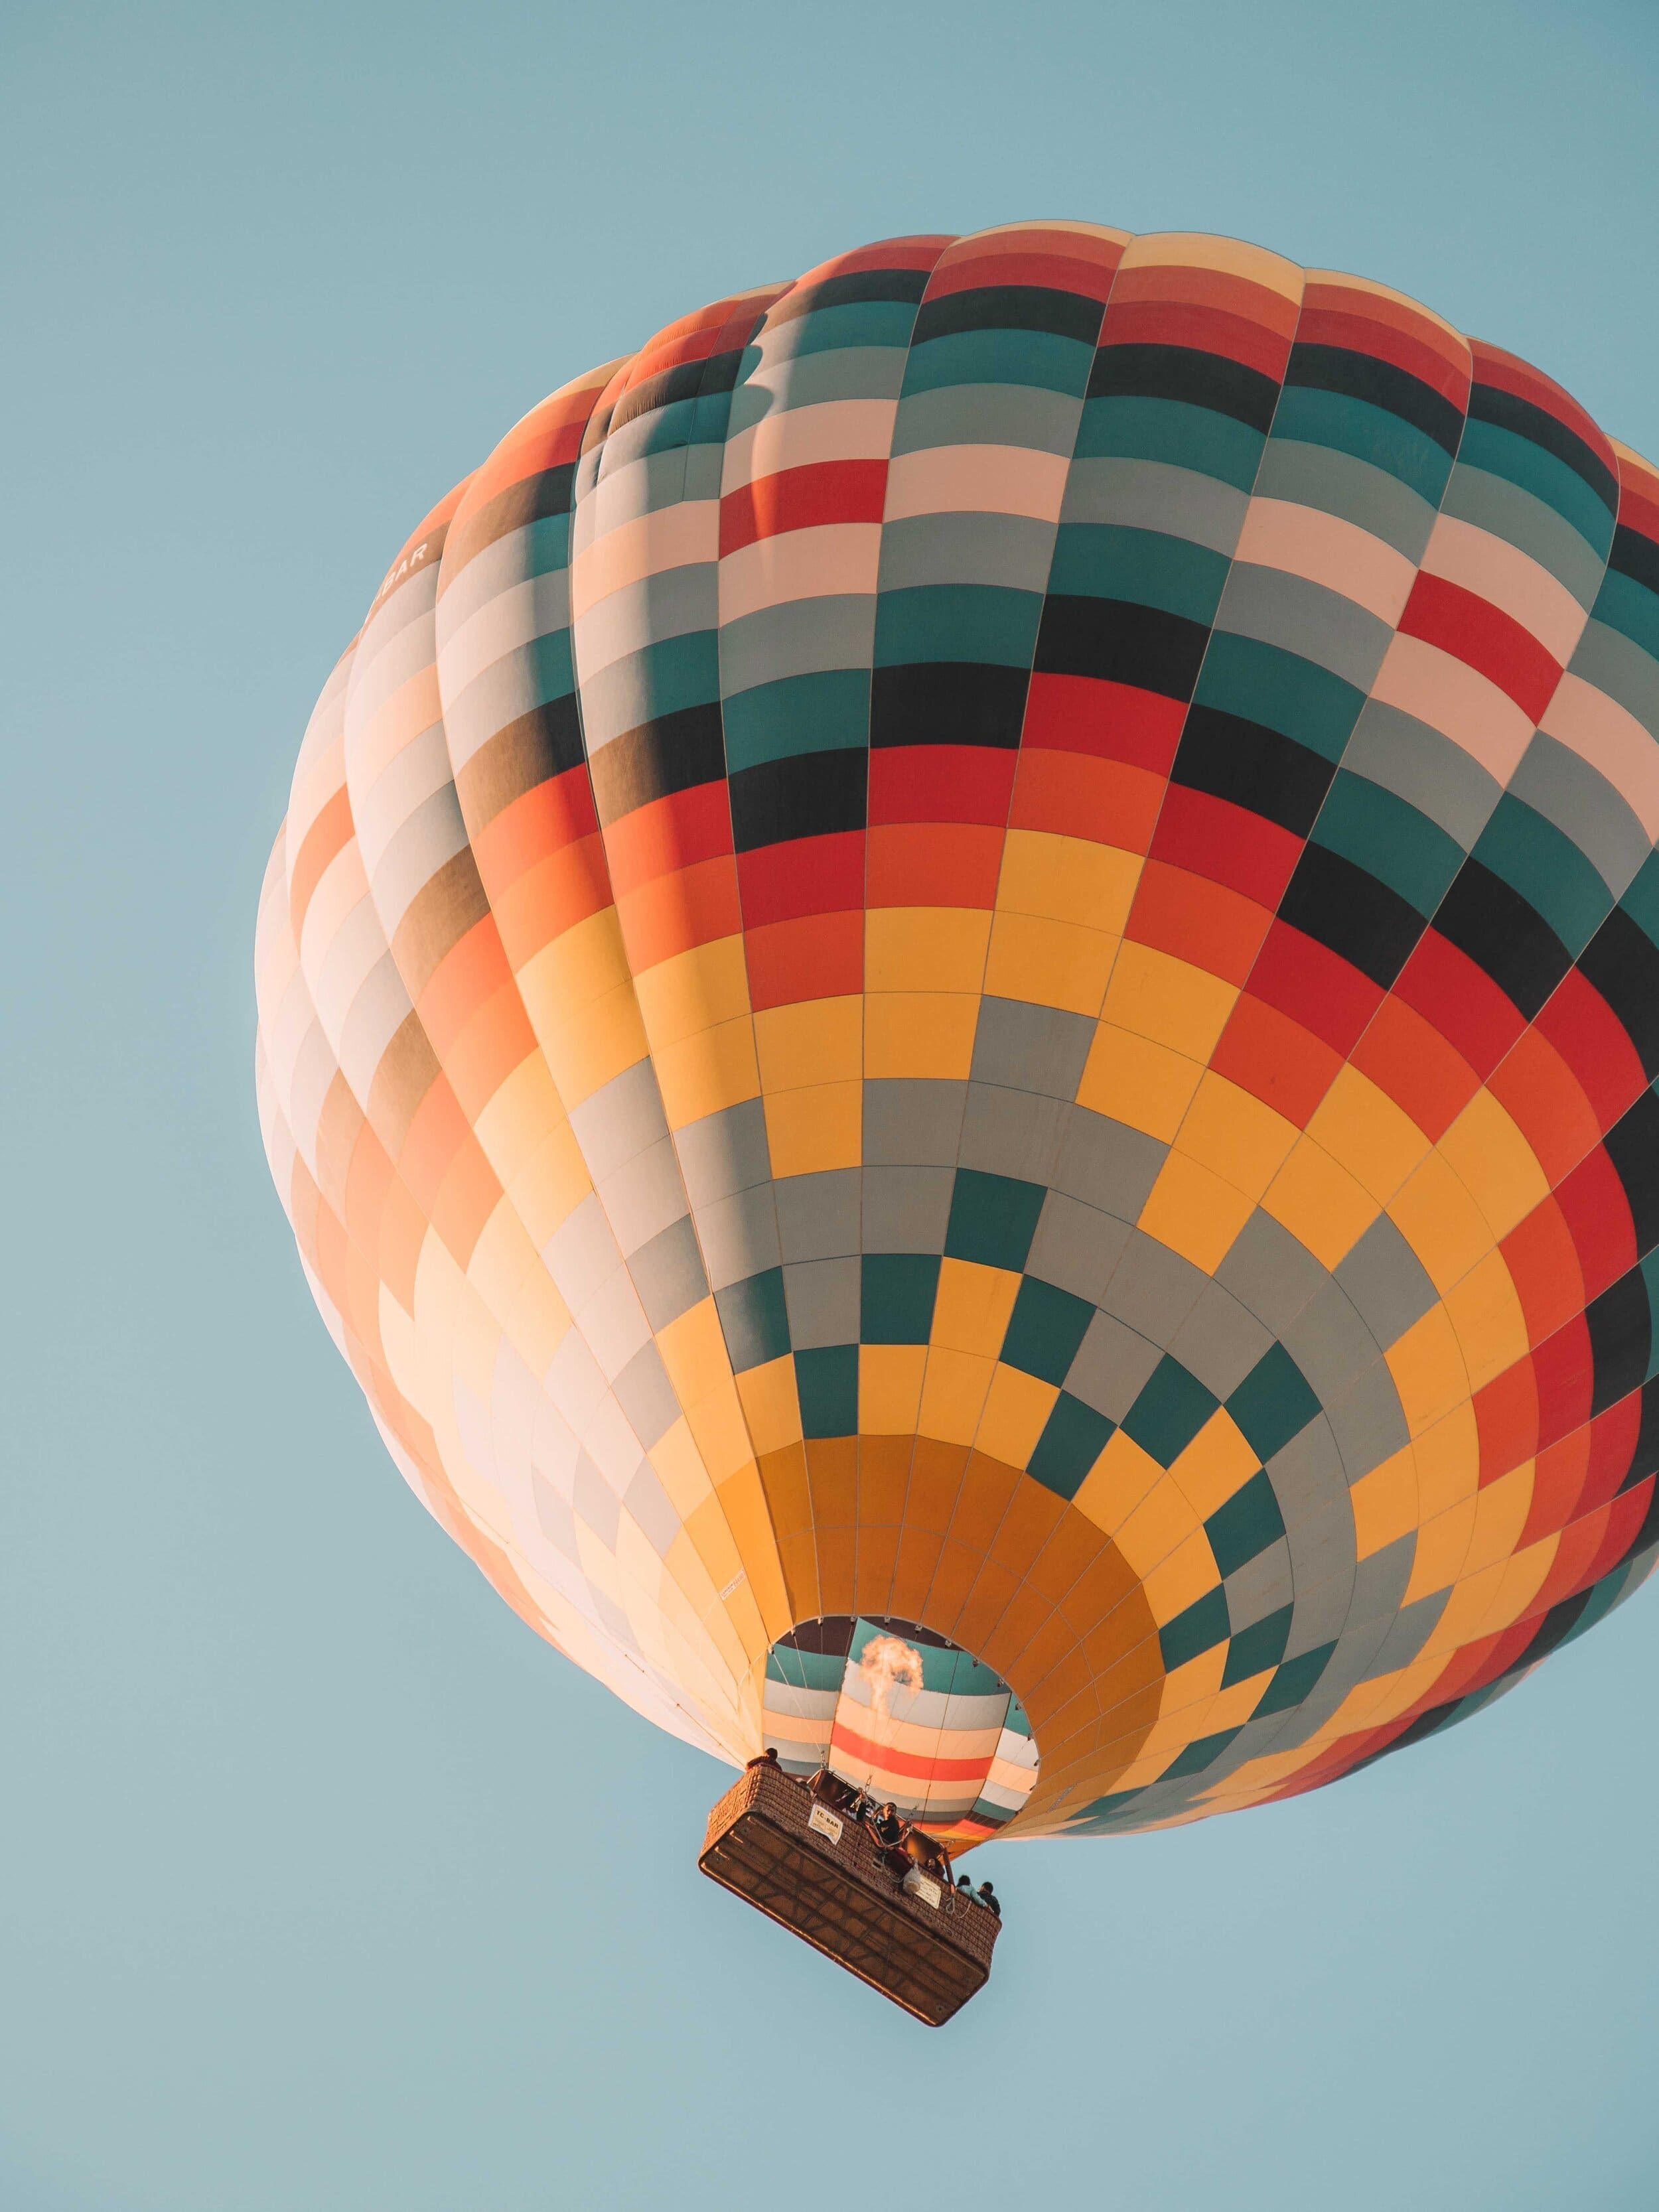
[0,0,1659,2212]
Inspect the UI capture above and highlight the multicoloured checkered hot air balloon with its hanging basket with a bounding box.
[257,224,1659,2013]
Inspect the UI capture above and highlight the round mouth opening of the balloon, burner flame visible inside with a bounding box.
[763,1612,1037,1845]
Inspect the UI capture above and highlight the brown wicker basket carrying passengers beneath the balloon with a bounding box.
[697,1761,1002,2028]
